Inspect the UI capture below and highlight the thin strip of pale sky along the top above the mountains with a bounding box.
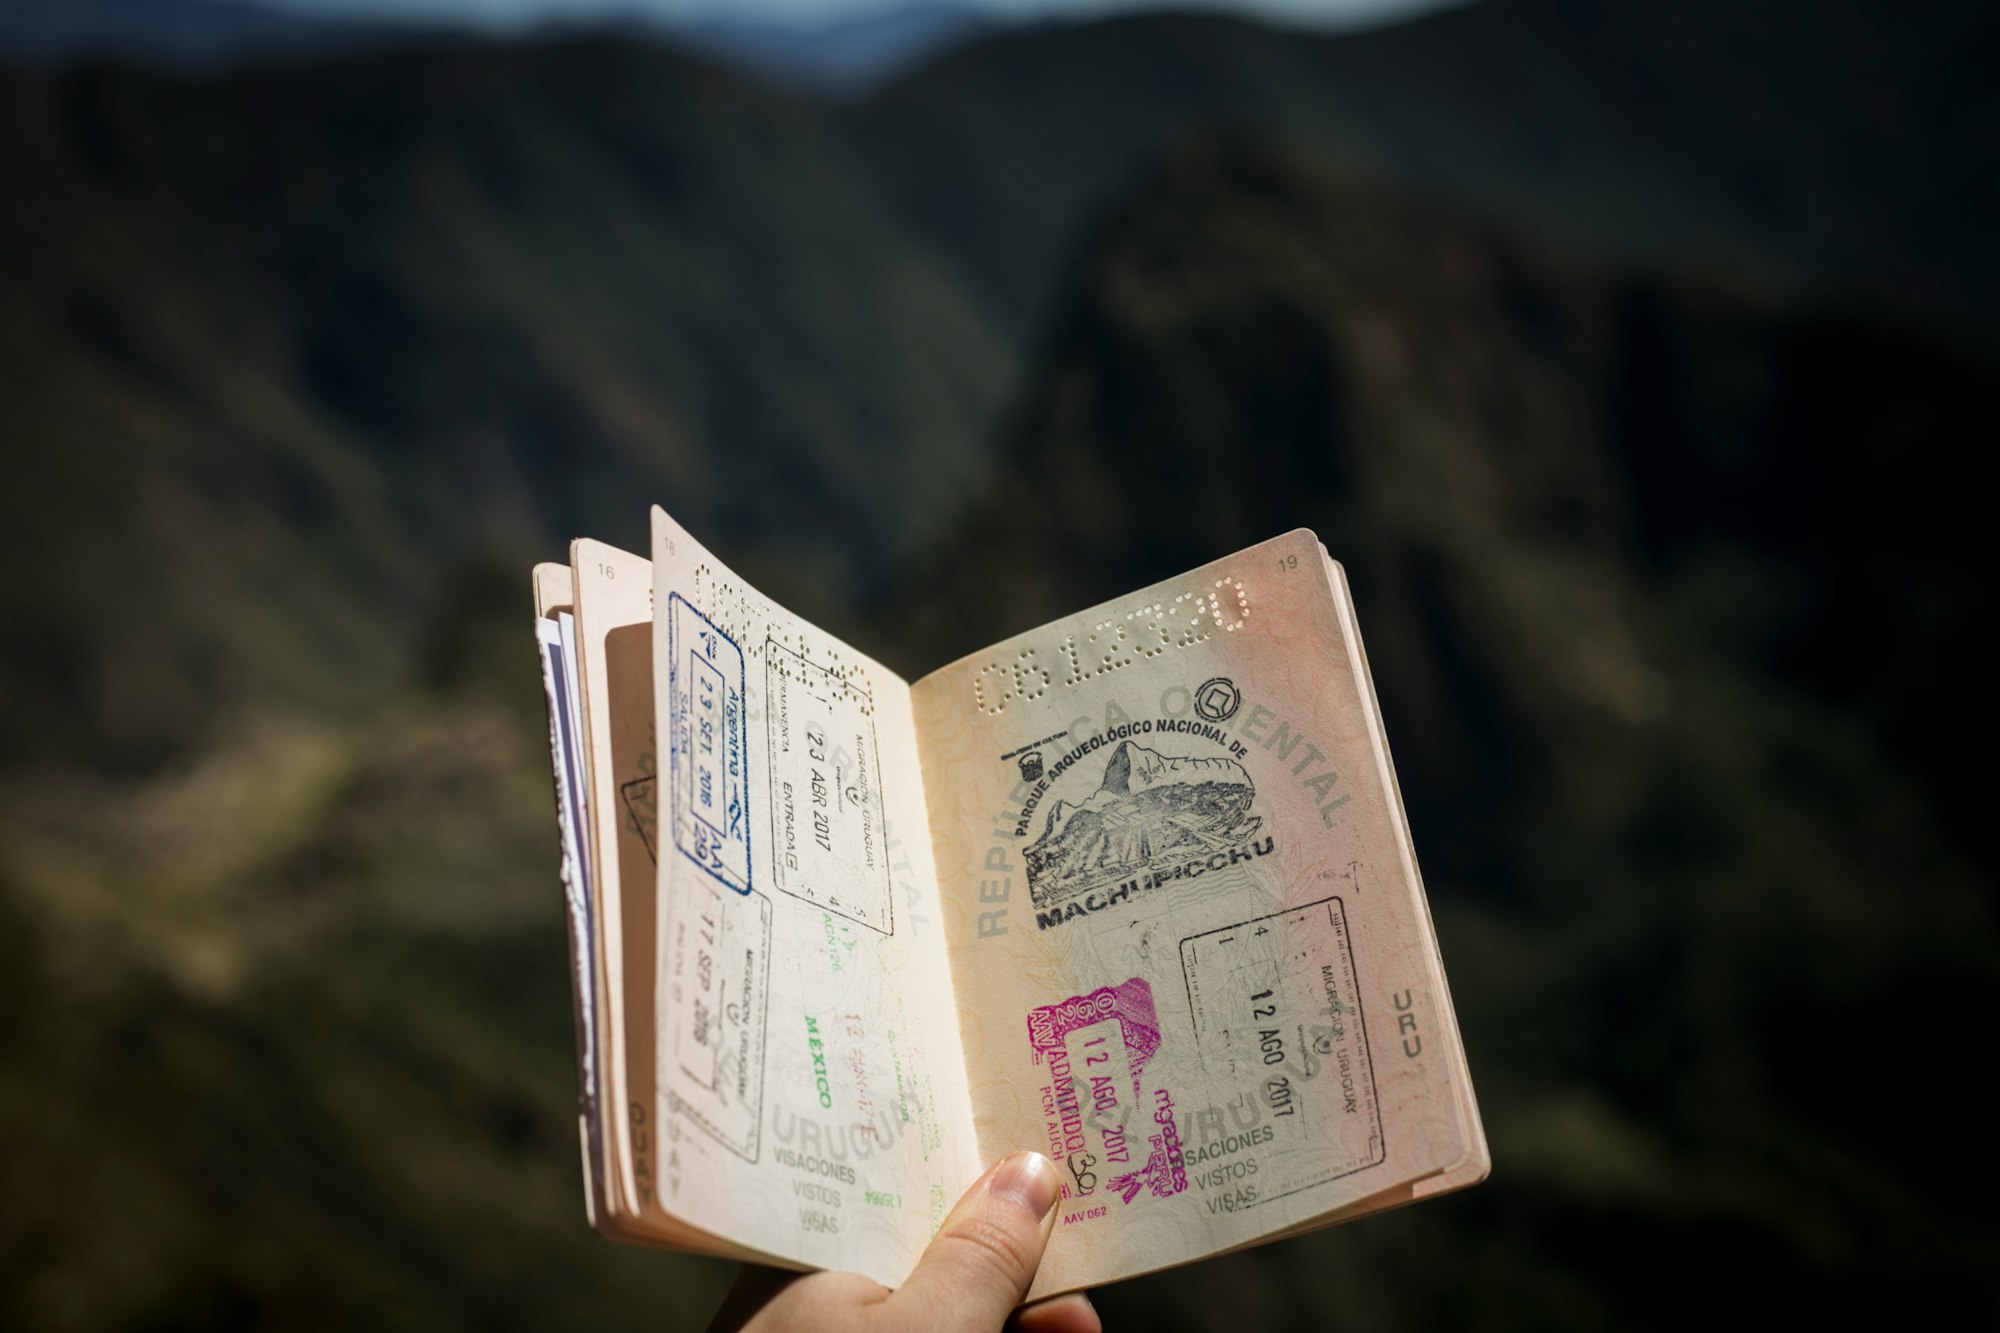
[264,0,1450,30]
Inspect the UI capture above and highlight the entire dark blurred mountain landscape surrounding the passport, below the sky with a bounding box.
[0,0,2000,1329]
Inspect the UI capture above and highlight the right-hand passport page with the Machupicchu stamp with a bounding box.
[912,530,1476,1297]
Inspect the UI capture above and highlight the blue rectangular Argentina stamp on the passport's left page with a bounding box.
[666,592,750,893]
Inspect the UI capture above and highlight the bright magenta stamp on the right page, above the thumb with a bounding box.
[1028,977,1188,1203]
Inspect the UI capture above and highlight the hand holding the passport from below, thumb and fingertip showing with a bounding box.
[708,1153,1102,1333]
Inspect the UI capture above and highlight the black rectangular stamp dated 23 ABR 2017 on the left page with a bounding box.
[764,638,896,935]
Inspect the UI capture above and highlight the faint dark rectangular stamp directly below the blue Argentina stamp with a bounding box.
[662,881,770,1161]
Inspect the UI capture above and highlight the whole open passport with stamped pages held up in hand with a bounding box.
[534,508,1488,1299]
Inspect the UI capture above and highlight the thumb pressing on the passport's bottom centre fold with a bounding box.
[888,1153,1062,1331]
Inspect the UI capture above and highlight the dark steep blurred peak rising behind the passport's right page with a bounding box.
[878,136,2000,1329]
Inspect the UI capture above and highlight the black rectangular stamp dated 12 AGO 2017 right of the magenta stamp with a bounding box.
[1180,897,1386,1207]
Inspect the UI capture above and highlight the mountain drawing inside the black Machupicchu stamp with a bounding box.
[1024,741,1264,909]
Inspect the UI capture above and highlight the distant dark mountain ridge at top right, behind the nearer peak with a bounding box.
[862,0,2000,340]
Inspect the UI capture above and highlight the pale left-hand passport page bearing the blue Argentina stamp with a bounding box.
[652,508,982,1285]
